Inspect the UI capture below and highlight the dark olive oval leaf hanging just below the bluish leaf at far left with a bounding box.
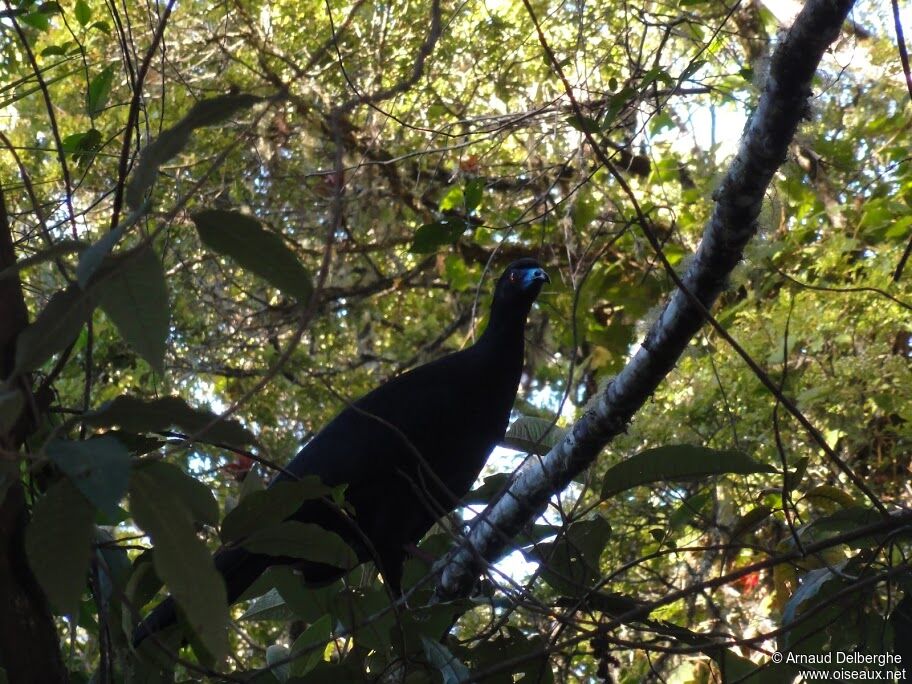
[25,478,95,615]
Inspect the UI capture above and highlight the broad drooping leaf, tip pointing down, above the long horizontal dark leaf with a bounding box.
[93,247,171,375]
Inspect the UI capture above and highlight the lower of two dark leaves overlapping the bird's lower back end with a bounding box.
[242,520,358,569]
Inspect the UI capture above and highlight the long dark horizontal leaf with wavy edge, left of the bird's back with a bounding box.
[82,395,256,446]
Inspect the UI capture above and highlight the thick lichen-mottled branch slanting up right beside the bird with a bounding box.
[437,0,853,598]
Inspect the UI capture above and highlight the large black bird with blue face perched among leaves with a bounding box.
[132,258,551,647]
